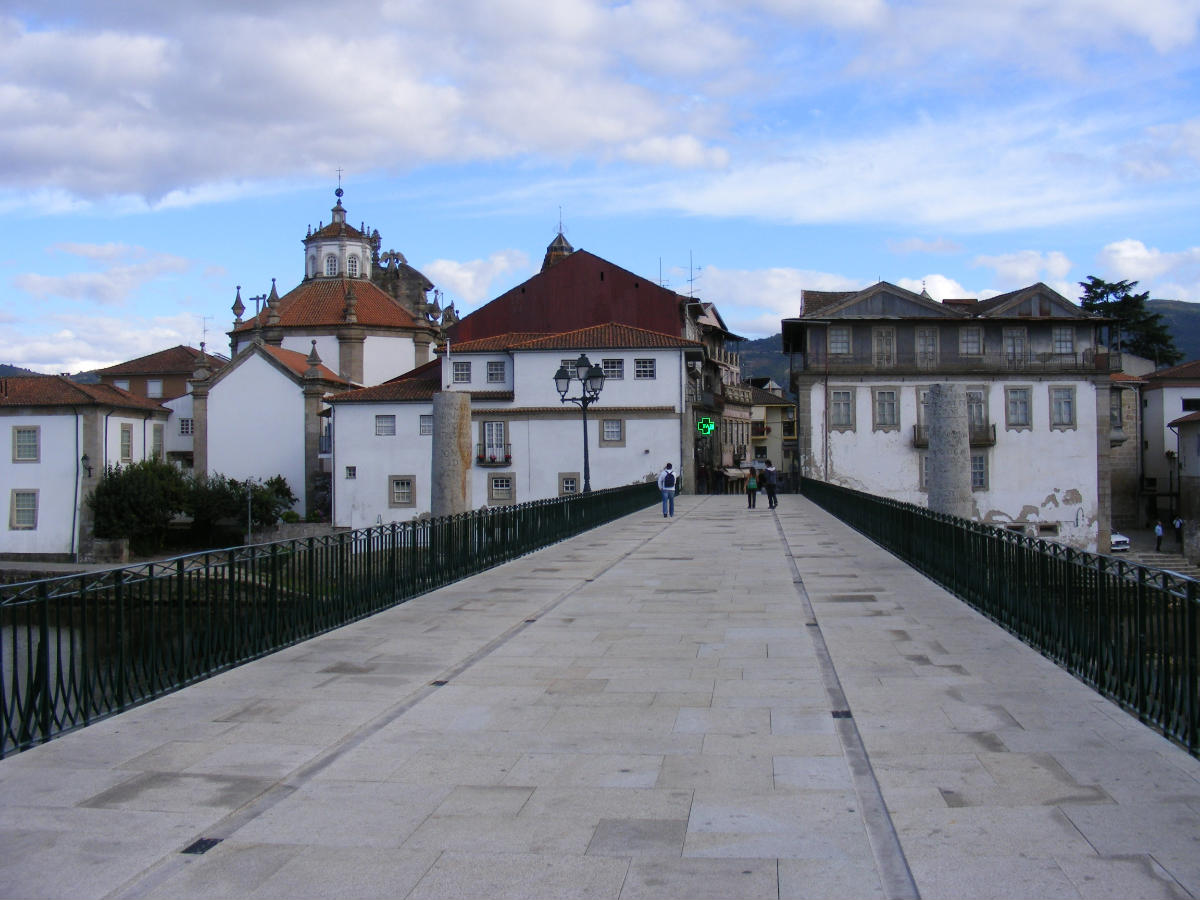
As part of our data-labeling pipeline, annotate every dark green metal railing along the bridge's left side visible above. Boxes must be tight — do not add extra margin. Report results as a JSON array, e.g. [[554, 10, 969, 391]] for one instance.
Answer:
[[0, 482, 660, 757]]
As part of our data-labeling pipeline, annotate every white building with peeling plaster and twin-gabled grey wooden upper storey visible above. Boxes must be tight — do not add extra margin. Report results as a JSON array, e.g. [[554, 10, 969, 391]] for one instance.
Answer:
[[784, 282, 1120, 550]]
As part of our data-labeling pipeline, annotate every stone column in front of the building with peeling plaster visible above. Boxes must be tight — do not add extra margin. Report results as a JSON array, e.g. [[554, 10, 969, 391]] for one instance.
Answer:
[[925, 384, 974, 518]]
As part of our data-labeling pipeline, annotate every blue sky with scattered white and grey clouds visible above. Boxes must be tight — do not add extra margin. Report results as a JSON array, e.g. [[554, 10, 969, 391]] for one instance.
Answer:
[[0, 0, 1200, 372]]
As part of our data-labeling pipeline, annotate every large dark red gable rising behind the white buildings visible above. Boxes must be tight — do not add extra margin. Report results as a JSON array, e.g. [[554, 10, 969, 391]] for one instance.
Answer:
[[450, 250, 688, 350]]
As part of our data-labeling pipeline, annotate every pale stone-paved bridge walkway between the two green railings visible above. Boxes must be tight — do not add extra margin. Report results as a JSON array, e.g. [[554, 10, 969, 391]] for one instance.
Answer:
[[0, 496, 1200, 900]]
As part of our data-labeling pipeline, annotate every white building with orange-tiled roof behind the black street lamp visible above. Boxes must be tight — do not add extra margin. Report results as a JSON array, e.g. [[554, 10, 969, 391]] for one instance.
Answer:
[[329, 324, 703, 528]]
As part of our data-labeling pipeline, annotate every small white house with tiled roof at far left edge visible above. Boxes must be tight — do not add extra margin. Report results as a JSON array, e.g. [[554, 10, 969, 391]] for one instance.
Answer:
[[0, 376, 168, 560]]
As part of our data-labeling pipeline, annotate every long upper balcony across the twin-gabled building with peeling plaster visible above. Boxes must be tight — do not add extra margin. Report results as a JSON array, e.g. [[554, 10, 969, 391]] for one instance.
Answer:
[[802, 348, 1121, 374]]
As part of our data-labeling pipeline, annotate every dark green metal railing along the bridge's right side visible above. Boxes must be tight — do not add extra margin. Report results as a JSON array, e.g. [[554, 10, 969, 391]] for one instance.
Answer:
[[800, 479, 1200, 756]]
